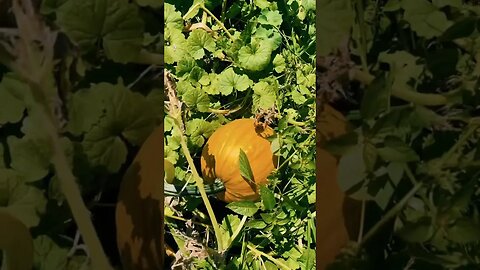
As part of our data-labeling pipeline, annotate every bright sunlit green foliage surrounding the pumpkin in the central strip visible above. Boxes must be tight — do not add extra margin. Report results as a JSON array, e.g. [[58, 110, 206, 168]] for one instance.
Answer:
[[164, 0, 316, 269]]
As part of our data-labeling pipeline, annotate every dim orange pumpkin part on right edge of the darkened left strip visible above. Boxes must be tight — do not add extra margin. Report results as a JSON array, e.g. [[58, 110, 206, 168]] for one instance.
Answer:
[[115, 126, 165, 270]]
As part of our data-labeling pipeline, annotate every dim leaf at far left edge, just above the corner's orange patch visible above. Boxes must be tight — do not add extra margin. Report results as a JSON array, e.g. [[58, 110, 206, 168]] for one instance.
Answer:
[[0, 169, 47, 228]]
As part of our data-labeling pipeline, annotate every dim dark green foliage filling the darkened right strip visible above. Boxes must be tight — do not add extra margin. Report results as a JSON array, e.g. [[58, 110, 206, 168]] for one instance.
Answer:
[[324, 0, 480, 269]]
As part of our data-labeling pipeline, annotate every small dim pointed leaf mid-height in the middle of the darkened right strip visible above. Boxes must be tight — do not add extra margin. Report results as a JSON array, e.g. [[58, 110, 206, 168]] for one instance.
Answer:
[[377, 136, 420, 163]]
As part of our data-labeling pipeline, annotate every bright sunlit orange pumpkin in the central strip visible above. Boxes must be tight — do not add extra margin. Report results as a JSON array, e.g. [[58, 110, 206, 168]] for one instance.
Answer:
[[200, 118, 278, 202]]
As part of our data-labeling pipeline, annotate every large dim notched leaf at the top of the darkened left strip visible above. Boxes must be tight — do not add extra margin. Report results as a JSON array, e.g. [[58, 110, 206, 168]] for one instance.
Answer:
[[57, 0, 144, 63]]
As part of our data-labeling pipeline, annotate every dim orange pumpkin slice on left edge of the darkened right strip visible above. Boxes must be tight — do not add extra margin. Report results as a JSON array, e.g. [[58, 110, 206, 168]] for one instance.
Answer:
[[316, 104, 361, 269]]
